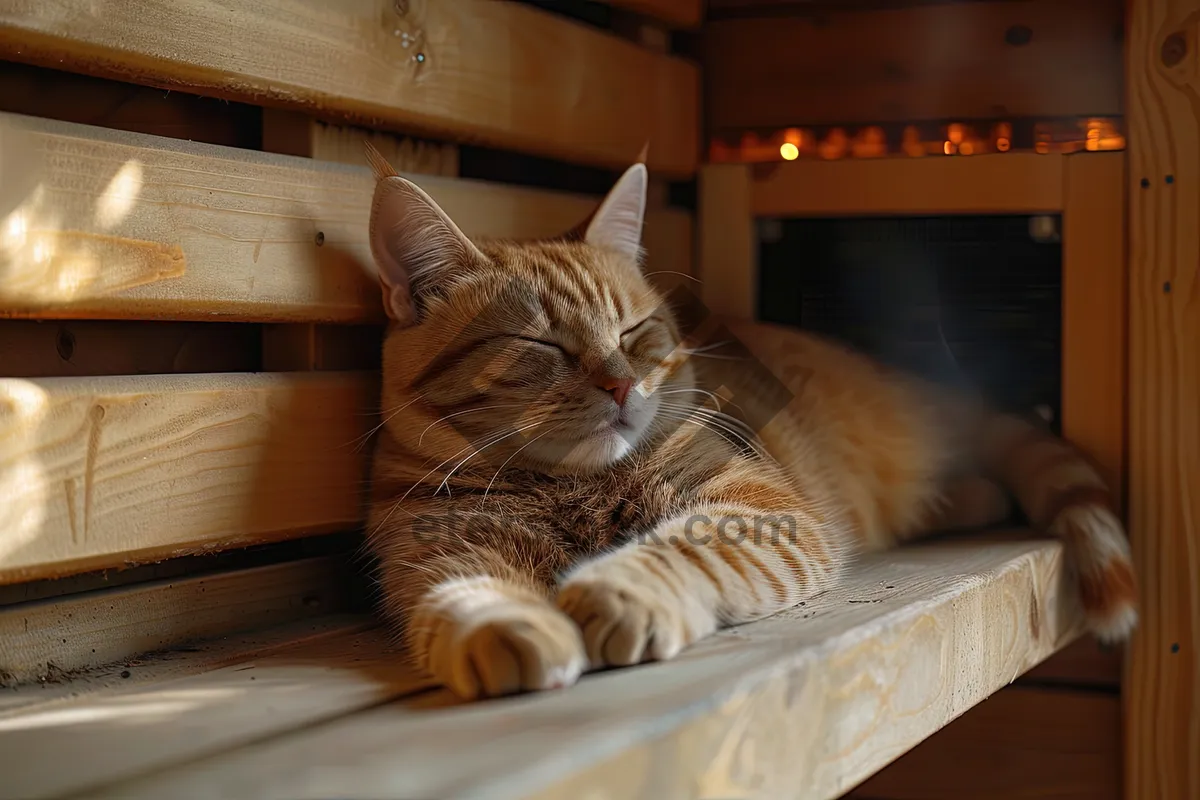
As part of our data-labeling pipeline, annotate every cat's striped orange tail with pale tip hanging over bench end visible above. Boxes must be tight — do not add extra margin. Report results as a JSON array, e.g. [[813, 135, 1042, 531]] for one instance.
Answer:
[[985, 414, 1138, 643]]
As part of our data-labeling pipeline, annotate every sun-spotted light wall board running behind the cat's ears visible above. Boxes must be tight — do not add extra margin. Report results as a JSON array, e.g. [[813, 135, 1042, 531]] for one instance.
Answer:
[[0, 114, 691, 323]]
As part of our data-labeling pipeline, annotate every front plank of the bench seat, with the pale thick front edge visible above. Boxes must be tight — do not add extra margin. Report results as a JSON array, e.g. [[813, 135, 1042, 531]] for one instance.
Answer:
[[89, 536, 1079, 800]]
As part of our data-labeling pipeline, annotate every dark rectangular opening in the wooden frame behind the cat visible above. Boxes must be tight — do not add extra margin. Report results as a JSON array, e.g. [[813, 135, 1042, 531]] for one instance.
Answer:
[[757, 209, 1062, 431]]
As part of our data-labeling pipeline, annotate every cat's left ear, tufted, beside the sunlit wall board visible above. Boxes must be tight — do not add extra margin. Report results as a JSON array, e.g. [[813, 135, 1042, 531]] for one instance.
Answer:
[[366, 143, 484, 325]]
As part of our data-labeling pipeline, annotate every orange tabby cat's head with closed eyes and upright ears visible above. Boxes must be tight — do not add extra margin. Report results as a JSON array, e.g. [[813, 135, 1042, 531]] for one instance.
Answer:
[[371, 148, 691, 473]]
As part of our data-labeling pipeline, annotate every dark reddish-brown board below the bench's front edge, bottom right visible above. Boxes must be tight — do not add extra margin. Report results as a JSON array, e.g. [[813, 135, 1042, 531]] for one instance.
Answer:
[[846, 686, 1121, 800]]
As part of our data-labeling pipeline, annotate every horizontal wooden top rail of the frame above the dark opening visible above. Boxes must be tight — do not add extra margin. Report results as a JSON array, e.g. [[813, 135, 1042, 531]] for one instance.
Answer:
[[751, 152, 1064, 217]]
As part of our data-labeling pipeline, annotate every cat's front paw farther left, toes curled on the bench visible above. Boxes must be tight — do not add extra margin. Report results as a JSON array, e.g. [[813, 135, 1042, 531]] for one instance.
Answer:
[[430, 603, 587, 699]]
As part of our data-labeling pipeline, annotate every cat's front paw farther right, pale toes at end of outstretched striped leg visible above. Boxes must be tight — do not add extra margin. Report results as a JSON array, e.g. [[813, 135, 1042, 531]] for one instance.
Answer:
[[557, 578, 715, 667]]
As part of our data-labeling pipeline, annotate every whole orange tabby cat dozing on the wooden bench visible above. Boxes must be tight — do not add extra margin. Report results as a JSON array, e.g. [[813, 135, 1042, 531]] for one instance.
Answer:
[[367, 146, 1136, 698]]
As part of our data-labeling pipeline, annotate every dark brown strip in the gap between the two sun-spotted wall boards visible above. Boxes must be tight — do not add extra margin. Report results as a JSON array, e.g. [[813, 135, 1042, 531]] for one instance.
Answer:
[[0, 319, 262, 378]]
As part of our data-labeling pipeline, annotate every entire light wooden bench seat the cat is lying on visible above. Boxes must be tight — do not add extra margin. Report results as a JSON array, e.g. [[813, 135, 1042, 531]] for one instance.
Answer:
[[0, 531, 1080, 800]]
